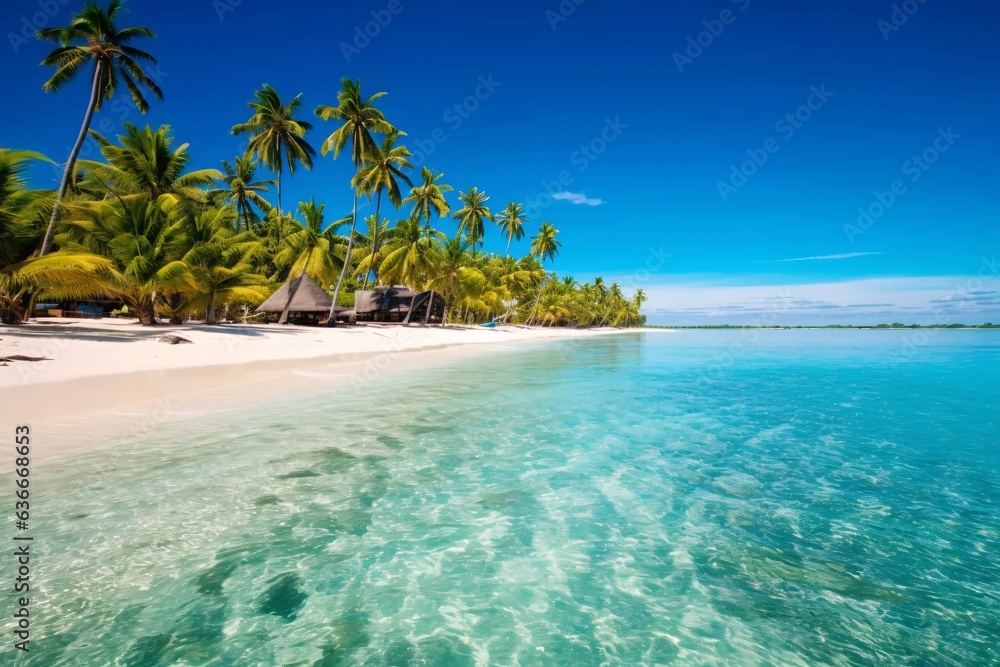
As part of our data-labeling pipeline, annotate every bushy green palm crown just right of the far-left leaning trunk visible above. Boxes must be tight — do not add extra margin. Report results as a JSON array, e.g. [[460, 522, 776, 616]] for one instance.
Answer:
[[79, 123, 222, 203]]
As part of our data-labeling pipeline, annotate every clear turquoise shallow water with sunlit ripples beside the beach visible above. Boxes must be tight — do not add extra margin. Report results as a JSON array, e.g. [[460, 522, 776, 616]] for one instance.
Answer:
[[9, 331, 1000, 667]]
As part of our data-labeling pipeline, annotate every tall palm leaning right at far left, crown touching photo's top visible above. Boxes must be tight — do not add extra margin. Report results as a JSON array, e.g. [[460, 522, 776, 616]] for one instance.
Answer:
[[38, 0, 163, 256]]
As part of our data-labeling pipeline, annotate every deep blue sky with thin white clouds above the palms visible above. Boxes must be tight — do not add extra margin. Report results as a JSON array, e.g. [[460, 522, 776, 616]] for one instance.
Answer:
[[0, 0, 1000, 324]]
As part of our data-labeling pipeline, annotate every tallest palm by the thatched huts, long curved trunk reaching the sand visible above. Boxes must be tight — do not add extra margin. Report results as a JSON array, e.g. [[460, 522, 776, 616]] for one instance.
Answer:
[[315, 78, 396, 326]]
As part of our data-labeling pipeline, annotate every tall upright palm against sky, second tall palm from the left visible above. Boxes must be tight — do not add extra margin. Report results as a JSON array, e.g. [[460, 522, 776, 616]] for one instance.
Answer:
[[232, 83, 316, 214]]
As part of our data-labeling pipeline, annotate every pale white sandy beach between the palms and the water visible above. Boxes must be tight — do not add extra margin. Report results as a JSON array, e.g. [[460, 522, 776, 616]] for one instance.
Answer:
[[0, 319, 636, 458]]
